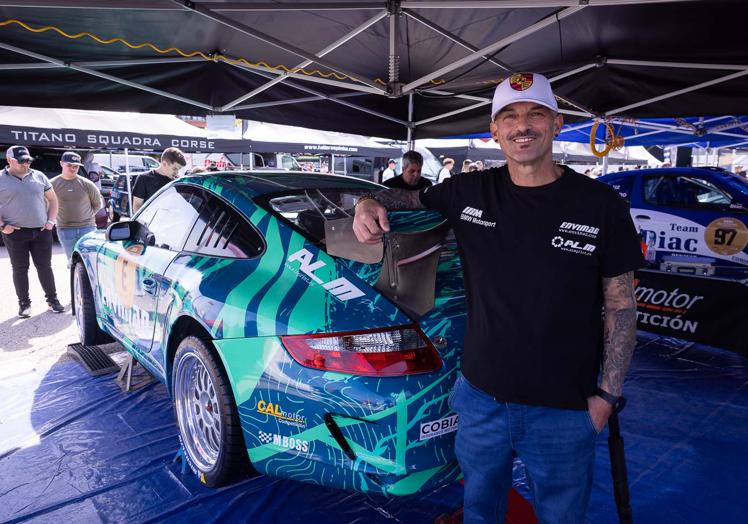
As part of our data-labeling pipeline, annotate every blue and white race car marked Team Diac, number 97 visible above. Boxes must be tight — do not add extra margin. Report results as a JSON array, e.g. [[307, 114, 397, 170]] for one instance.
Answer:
[[598, 168, 748, 276]]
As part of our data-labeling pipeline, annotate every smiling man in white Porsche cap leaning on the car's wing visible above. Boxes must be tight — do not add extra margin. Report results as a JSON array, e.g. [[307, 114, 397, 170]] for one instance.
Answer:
[[353, 73, 643, 523]]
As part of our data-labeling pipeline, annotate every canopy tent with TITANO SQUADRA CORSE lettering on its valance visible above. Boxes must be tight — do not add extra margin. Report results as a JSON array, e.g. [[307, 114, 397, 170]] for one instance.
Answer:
[[0, 106, 250, 152]]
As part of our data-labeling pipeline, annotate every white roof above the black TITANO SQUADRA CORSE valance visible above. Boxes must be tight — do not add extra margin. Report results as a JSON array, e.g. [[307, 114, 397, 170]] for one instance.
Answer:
[[0, 106, 206, 137]]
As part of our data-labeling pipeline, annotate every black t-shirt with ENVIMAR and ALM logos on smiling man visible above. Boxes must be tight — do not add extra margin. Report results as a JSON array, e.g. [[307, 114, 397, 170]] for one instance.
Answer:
[[420, 166, 643, 410]]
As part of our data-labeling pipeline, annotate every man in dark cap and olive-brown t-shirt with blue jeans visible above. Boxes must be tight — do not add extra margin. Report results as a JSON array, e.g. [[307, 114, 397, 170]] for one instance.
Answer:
[[52, 151, 102, 267]]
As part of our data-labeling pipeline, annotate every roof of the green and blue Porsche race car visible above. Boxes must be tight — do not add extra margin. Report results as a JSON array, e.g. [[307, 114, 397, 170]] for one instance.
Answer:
[[179, 170, 382, 198]]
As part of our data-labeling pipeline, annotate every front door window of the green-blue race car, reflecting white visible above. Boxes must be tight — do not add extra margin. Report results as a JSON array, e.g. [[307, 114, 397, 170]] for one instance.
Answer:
[[135, 185, 206, 251]]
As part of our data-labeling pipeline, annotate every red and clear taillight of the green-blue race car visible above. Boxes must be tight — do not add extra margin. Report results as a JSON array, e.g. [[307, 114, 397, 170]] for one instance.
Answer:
[[281, 326, 442, 377]]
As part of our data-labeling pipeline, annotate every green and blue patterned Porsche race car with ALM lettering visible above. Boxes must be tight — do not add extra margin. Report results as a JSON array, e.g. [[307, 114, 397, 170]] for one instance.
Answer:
[[71, 171, 466, 495]]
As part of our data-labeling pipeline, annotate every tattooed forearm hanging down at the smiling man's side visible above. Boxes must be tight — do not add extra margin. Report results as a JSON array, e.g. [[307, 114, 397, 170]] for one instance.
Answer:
[[601, 272, 636, 396]]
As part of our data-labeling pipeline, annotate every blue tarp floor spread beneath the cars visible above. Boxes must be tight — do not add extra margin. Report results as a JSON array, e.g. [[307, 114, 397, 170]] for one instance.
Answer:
[[0, 333, 748, 524]]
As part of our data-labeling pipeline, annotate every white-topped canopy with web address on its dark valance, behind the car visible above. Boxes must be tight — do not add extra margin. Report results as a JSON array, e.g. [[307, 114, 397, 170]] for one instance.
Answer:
[[244, 121, 401, 157]]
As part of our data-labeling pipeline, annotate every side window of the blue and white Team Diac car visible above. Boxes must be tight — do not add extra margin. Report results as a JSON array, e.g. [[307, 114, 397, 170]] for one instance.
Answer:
[[644, 175, 732, 210]]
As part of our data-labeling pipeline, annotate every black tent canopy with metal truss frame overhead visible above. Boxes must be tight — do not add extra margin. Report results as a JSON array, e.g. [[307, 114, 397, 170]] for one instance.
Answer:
[[0, 0, 748, 139]]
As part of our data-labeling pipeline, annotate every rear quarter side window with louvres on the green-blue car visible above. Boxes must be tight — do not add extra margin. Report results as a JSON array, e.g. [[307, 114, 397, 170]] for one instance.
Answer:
[[184, 195, 265, 258]]
